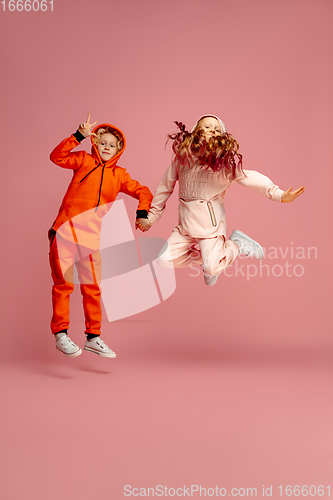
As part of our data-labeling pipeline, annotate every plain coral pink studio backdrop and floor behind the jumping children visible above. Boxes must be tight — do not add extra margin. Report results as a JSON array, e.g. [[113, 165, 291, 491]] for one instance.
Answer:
[[0, 0, 333, 500]]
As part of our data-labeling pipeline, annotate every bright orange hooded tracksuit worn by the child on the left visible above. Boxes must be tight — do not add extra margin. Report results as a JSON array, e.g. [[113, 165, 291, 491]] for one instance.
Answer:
[[49, 123, 153, 335]]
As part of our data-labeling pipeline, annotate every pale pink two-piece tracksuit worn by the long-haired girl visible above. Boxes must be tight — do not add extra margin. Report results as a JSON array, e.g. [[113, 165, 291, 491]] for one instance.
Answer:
[[148, 120, 283, 276]]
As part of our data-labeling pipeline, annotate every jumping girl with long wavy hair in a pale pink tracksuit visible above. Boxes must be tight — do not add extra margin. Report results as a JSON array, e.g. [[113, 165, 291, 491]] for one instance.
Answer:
[[136, 115, 305, 286]]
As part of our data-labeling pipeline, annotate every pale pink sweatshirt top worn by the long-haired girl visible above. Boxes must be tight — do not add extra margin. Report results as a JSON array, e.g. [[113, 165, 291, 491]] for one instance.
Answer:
[[148, 163, 283, 238]]
